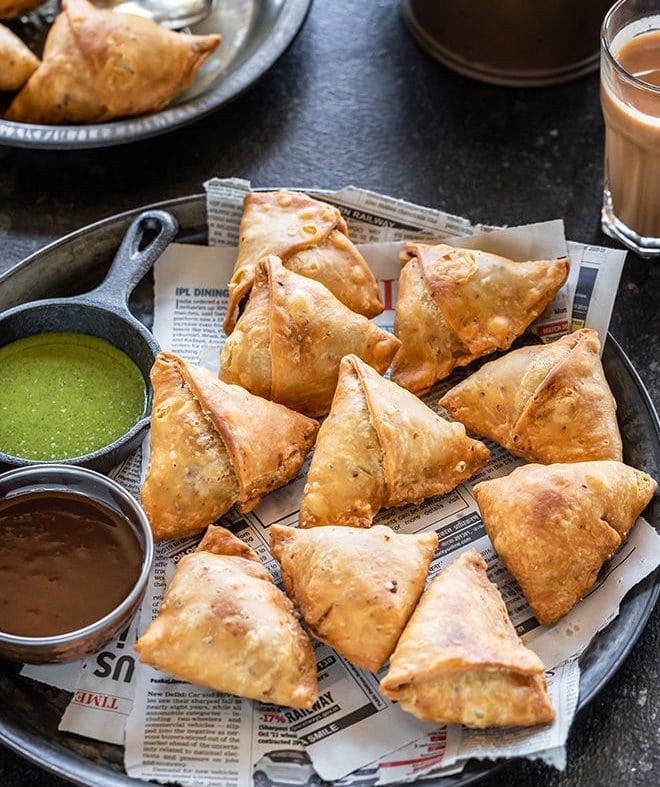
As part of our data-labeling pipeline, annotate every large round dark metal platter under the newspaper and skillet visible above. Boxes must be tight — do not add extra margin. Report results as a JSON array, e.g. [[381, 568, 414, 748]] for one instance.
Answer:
[[0, 195, 660, 787]]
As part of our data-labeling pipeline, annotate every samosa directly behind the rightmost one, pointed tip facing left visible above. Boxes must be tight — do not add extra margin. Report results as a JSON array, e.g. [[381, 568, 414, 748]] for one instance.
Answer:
[[440, 328, 622, 464]]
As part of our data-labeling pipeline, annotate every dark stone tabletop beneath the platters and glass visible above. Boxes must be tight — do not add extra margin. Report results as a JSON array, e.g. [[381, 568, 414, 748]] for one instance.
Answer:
[[0, 0, 660, 787]]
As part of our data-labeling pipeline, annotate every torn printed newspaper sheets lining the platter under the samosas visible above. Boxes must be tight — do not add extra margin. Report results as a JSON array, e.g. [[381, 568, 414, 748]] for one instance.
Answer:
[[22, 179, 660, 787]]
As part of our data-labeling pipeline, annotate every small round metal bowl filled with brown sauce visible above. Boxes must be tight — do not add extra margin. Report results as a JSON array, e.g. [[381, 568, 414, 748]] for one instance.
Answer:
[[0, 464, 154, 664]]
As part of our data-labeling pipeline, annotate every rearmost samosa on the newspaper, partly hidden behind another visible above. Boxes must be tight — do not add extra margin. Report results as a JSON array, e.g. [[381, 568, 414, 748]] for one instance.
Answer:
[[225, 189, 383, 334]]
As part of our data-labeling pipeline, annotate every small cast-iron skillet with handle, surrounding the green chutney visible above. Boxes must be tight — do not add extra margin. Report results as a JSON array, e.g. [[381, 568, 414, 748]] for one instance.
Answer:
[[0, 210, 178, 473]]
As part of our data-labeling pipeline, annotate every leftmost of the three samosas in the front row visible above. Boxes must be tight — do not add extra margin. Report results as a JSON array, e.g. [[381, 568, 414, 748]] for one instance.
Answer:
[[135, 526, 318, 708]]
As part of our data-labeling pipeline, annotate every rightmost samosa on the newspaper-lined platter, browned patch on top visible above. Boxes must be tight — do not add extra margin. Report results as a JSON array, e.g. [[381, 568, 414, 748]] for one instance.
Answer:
[[474, 461, 656, 626]]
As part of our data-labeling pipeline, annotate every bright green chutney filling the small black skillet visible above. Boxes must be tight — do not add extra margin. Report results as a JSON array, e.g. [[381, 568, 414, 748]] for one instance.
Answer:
[[0, 332, 147, 461]]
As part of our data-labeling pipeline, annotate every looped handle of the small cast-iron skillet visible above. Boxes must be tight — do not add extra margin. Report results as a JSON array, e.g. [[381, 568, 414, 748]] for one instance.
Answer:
[[83, 210, 179, 309]]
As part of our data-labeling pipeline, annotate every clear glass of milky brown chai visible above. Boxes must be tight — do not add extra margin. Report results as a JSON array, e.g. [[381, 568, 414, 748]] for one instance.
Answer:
[[600, 0, 660, 257]]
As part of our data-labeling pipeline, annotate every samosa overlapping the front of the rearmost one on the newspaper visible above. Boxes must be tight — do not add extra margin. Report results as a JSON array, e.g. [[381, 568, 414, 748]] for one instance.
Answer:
[[220, 255, 399, 416]]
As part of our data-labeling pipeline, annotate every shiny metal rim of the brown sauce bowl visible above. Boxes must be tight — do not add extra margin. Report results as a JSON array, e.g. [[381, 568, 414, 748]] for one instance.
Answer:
[[0, 463, 155, 652]]
